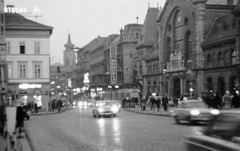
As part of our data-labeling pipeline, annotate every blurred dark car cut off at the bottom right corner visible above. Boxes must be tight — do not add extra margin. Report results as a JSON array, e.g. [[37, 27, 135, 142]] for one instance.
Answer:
[[184, 109, 240, 151]]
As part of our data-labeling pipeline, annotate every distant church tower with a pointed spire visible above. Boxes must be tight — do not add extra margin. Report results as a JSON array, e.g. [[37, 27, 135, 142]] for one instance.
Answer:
[[63, 33, 76, 69]]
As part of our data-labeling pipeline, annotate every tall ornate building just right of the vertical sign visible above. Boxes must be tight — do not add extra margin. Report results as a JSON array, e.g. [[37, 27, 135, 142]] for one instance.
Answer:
[[117, 24, 142, 89]]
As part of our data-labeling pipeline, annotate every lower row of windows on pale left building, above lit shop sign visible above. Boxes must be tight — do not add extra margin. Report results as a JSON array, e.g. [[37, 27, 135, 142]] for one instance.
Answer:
[[8, 63, 42, 79]]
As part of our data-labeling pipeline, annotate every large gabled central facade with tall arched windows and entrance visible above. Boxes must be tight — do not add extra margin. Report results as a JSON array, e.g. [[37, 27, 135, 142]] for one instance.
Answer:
[[157, 0, 237, 97]]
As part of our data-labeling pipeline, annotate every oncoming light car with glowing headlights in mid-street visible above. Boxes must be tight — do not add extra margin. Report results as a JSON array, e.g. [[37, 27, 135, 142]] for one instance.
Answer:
[[92, 100, 120, 118]]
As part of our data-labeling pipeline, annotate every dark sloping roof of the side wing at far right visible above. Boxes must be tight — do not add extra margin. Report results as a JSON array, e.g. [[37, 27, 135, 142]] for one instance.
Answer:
[[202, 14, 237, 47]]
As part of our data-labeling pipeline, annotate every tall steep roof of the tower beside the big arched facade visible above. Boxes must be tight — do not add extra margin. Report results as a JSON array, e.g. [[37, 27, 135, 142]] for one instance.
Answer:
[[136, 8, 159, 49]]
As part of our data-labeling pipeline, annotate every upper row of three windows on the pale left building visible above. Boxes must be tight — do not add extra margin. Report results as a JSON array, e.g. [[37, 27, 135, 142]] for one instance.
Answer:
[[6, 42, 40, 54]]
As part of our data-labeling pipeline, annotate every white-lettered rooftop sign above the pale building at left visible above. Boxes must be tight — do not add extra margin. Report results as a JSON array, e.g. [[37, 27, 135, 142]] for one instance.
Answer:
[[4, 6, 42, 16]]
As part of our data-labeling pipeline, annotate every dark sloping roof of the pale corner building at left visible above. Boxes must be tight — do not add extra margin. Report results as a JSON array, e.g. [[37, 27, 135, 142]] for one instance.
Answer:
[[5, 13, 53, 33]]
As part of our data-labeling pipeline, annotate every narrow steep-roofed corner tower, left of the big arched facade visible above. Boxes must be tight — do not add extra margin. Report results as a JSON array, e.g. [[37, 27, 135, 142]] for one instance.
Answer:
[[134, 7, 160, 95]]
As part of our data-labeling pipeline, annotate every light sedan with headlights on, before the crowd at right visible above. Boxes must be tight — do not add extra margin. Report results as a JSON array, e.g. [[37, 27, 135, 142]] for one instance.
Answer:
[[170, 100, 219, 124]]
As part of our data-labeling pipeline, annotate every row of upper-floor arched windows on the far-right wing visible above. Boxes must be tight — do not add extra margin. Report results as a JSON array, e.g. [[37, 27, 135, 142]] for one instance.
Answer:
[[206, 50, 236, 67]]
